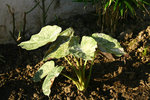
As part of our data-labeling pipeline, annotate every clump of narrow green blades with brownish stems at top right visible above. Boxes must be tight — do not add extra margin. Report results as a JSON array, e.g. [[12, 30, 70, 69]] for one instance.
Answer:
[[74, 0, 150, 35]]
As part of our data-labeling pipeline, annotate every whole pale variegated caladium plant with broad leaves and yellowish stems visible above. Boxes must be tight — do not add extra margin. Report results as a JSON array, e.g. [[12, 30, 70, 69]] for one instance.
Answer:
[[19, 25, 125, 96]]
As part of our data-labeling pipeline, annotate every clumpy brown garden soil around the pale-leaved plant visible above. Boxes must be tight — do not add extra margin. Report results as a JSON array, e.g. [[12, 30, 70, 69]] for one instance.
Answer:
[[0, 13, 150, 100]]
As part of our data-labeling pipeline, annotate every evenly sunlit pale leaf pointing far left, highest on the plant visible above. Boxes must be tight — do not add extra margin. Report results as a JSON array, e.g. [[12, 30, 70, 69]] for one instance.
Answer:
[[19, 25, 61, 50]]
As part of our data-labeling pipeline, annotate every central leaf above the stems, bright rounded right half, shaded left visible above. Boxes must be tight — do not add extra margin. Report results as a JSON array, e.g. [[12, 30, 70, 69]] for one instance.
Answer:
[[70, 36, 97, 60]]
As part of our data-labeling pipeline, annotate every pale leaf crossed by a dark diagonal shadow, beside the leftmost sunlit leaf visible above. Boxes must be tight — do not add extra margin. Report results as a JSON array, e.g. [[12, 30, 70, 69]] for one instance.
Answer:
[[44, 28, 74, 60]]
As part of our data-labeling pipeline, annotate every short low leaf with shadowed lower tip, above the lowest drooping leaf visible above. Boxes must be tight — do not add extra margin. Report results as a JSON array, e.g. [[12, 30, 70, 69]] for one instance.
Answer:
[[33, 61, 55, 82]]
